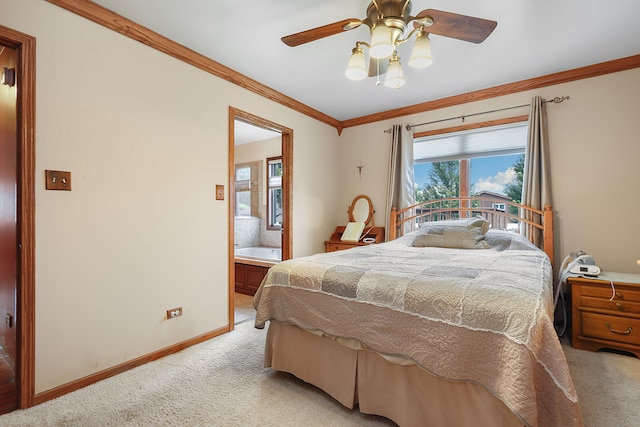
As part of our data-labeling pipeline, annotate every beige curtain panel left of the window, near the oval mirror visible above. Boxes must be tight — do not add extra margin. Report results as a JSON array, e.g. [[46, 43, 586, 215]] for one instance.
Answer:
[[385, 124, 415, 240]]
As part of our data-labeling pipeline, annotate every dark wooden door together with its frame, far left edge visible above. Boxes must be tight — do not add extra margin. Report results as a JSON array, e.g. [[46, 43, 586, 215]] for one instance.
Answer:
[[0, 25, 39, 411]]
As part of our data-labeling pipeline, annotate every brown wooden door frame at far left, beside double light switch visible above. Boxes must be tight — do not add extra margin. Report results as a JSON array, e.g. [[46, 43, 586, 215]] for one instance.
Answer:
[[0, 25, 36, 408]]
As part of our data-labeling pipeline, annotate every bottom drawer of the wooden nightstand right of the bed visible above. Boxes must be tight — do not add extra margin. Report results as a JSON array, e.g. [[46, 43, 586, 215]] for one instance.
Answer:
[[581, 312, 640, 345]]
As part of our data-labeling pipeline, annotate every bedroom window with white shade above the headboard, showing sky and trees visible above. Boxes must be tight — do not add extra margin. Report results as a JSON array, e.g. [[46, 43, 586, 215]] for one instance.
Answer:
[[413, 122, 527, 204]]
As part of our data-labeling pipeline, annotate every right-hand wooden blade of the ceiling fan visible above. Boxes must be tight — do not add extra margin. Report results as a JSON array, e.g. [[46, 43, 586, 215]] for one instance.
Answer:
[[413, 9, 498, 43]]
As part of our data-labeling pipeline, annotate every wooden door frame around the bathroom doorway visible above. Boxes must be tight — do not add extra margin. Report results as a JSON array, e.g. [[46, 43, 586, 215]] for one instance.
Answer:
[[227, 107, 293, 330]]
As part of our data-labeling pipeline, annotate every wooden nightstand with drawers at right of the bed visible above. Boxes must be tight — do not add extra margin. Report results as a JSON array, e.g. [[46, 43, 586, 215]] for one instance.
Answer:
[[567, 272, 640, 357]]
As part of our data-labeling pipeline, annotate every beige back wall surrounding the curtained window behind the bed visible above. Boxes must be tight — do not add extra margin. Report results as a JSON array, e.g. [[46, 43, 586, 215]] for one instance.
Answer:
[[340, 69, 640, 273]]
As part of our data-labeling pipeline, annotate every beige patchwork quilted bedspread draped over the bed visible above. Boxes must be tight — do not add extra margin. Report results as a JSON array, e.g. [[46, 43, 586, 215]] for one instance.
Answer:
[[255, 236, 580, 426]]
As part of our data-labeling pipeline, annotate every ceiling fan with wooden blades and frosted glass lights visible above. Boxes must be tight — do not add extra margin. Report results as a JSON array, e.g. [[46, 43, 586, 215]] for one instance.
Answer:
[[281, 0, 498, 88]]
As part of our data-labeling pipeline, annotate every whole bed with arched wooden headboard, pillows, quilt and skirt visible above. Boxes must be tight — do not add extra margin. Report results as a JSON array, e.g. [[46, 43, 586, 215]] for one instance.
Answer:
[[254, 198, 582, 426]]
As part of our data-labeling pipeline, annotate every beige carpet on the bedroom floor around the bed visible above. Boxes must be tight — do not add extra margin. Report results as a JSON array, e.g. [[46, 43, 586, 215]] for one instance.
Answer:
[[0, 321, 640, 427]]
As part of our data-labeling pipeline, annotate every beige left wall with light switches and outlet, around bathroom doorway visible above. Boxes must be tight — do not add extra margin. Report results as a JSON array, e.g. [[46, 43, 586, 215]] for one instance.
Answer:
[[0, 0, 339, 392]]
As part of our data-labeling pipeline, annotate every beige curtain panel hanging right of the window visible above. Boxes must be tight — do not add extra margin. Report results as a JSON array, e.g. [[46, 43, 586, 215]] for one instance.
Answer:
[[522, 96, 551, 245]]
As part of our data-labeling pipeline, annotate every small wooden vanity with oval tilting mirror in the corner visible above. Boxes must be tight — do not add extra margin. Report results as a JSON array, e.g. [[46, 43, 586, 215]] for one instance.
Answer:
[[324, 195, 384, 252]]
